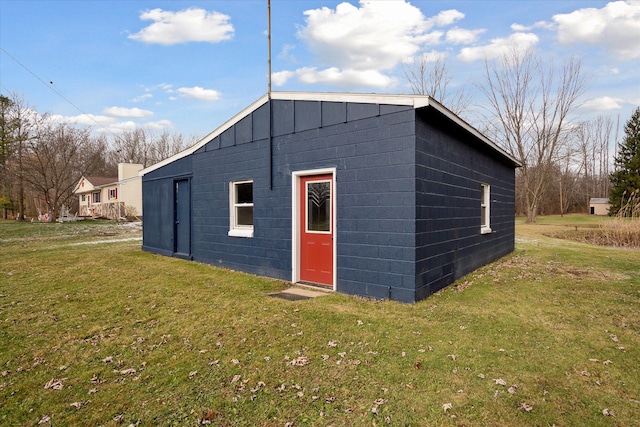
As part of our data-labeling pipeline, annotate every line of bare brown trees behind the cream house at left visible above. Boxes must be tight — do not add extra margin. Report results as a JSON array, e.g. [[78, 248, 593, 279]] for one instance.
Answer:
[[0, 95, 195, 219]]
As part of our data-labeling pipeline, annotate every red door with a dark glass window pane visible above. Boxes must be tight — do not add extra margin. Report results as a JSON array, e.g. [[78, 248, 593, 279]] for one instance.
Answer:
[[300, 174, 333, 286]]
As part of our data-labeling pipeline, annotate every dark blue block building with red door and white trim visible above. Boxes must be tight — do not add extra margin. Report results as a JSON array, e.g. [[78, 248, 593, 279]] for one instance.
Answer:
[[141, 92, 520, 302]]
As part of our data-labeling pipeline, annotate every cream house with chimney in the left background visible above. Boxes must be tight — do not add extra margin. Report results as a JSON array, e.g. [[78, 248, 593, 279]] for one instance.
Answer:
[[73, 163, 143, 219]]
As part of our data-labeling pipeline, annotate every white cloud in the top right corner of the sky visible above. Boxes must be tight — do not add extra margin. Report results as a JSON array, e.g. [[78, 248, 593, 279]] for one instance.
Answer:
[[552, 0, 640, 59]]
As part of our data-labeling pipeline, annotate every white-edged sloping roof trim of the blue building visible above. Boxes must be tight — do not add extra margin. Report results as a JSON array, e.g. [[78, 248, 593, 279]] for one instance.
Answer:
[[139, 92, 522, 176]]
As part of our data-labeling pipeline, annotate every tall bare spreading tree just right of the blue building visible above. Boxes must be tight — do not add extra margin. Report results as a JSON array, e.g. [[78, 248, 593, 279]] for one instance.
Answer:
[[482, 49, 586, 223]]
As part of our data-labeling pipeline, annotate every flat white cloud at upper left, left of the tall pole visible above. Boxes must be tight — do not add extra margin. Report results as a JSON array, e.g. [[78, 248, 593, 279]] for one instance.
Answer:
[[129, 8, 234, 45]]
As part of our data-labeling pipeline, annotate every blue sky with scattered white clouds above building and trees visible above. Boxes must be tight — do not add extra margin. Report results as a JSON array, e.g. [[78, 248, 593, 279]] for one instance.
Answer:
[[0, 0, 640, 139]]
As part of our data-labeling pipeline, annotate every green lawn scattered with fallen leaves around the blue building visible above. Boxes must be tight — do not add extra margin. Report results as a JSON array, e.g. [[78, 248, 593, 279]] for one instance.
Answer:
[[0, 216, 640, 426]]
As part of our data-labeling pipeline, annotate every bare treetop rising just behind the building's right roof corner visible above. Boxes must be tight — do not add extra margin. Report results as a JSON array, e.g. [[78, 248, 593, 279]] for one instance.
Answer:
[[403, 52, 472, 116]]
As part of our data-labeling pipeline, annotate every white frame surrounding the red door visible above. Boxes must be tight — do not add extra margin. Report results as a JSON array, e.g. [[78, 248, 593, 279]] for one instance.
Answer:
[[291, 168, 338, 291]]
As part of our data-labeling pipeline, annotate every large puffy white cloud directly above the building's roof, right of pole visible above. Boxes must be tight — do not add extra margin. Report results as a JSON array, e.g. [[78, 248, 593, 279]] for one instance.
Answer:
[[280, 0, 474, 89]]
